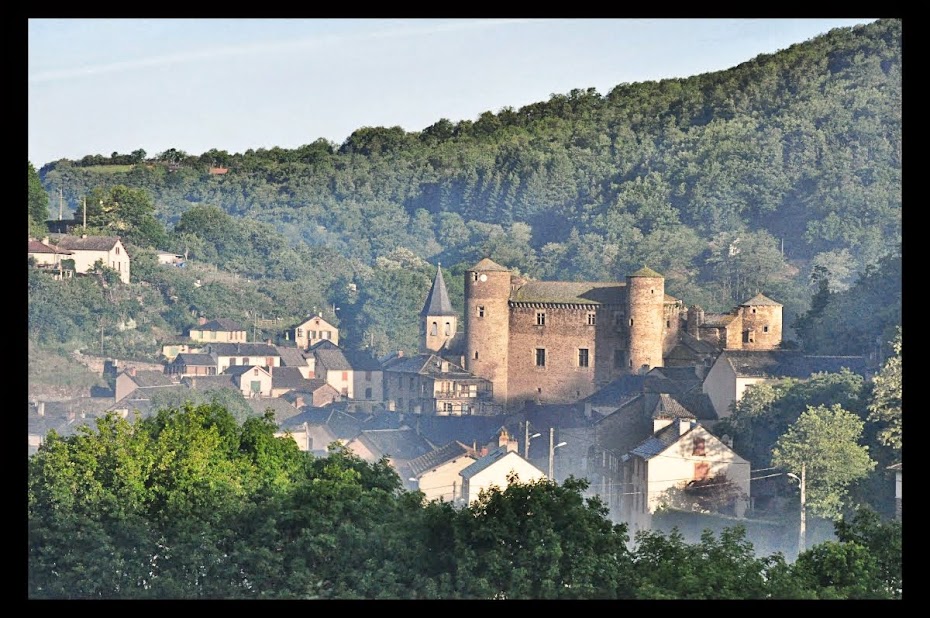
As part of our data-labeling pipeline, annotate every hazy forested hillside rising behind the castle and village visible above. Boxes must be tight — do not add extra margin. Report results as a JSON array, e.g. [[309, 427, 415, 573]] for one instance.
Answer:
[[30, 20, 902, 354]]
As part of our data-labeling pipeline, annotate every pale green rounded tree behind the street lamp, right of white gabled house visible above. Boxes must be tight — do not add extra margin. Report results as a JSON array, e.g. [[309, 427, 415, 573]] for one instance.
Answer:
[[772, 404, 875, 520]]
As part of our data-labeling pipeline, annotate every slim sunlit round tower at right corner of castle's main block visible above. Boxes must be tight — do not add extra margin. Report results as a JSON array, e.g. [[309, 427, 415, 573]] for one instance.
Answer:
[[626, 266, 665, 373]]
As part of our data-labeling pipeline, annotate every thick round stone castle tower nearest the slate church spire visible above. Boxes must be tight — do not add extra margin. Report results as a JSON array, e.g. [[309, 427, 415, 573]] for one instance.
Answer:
[[465, 258, 511, 404]]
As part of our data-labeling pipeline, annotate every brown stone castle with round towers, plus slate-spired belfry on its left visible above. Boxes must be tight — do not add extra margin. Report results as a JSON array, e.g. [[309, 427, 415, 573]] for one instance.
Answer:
[[420, 258, 782, 407]]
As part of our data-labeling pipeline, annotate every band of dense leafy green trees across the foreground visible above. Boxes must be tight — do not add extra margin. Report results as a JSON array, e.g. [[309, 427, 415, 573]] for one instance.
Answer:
[[28, 404, 903, 600]]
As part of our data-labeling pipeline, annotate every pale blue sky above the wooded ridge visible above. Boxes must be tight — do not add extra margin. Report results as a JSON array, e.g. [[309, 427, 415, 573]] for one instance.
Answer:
[[28, 18, 875, 169]]
